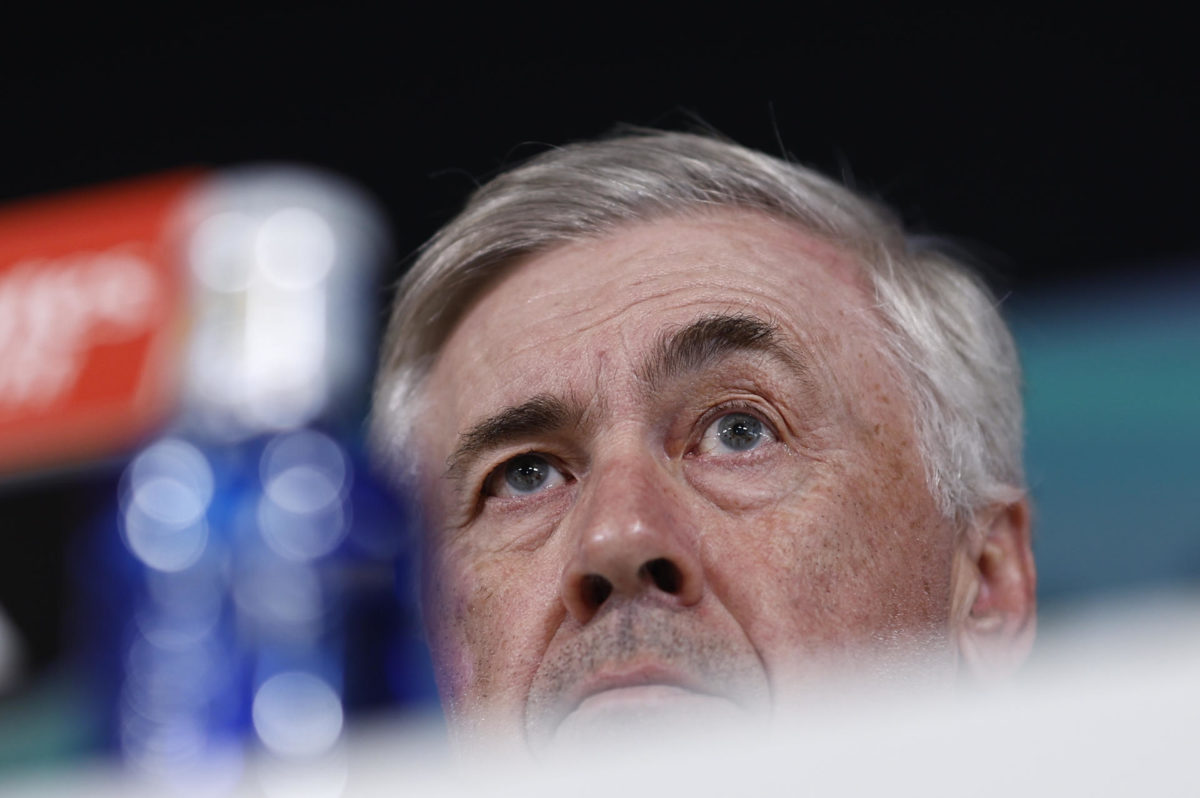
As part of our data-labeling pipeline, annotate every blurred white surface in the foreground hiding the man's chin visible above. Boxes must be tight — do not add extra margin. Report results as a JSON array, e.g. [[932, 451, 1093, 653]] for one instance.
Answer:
[[9, 595, 1200, 798]]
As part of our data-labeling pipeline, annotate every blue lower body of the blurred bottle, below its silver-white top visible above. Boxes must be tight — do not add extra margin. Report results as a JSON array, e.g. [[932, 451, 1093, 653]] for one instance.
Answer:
[[76, 428, 434, 780]]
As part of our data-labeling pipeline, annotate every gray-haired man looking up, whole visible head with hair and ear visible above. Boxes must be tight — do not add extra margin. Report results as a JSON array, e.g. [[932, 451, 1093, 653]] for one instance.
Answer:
[[373, 127, 1034, 750]]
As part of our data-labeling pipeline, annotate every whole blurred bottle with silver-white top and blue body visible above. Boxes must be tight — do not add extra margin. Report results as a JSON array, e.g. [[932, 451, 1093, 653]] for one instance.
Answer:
[[58, 168, 433, 786]]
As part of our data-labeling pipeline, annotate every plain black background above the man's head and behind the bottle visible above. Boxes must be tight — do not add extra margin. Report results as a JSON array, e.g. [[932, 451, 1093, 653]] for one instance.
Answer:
[[0, 2, 1200, 686]]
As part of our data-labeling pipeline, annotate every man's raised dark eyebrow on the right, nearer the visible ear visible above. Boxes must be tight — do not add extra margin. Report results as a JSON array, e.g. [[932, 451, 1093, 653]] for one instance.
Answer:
[[640, 313, 811, 386]]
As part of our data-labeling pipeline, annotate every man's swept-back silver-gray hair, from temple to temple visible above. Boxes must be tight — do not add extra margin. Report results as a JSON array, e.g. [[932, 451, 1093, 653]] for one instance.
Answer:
[[371, 131, 1024, 522]]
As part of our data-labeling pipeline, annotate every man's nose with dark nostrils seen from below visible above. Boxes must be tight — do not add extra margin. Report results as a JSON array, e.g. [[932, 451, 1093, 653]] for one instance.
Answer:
[[562, 457, 704, 624]]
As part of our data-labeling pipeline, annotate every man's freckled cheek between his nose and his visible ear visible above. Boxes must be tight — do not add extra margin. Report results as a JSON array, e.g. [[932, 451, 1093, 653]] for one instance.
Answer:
[[707, 458, 950, 667]]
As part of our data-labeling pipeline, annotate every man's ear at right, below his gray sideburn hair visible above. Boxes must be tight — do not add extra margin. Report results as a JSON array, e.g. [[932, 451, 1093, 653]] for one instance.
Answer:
[[954, 496, 1037, 680]]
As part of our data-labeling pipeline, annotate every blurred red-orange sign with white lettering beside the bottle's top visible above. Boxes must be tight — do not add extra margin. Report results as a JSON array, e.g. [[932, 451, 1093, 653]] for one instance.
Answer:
[[0, 173, 202, 473]]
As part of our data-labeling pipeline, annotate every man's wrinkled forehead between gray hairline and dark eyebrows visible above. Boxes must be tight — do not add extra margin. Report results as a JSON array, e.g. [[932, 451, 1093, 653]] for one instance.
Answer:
[[427, 211, 874, 448]]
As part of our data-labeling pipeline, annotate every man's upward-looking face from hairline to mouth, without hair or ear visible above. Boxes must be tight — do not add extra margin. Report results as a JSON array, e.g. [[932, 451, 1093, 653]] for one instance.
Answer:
[[415, 211, 961, 749]]
